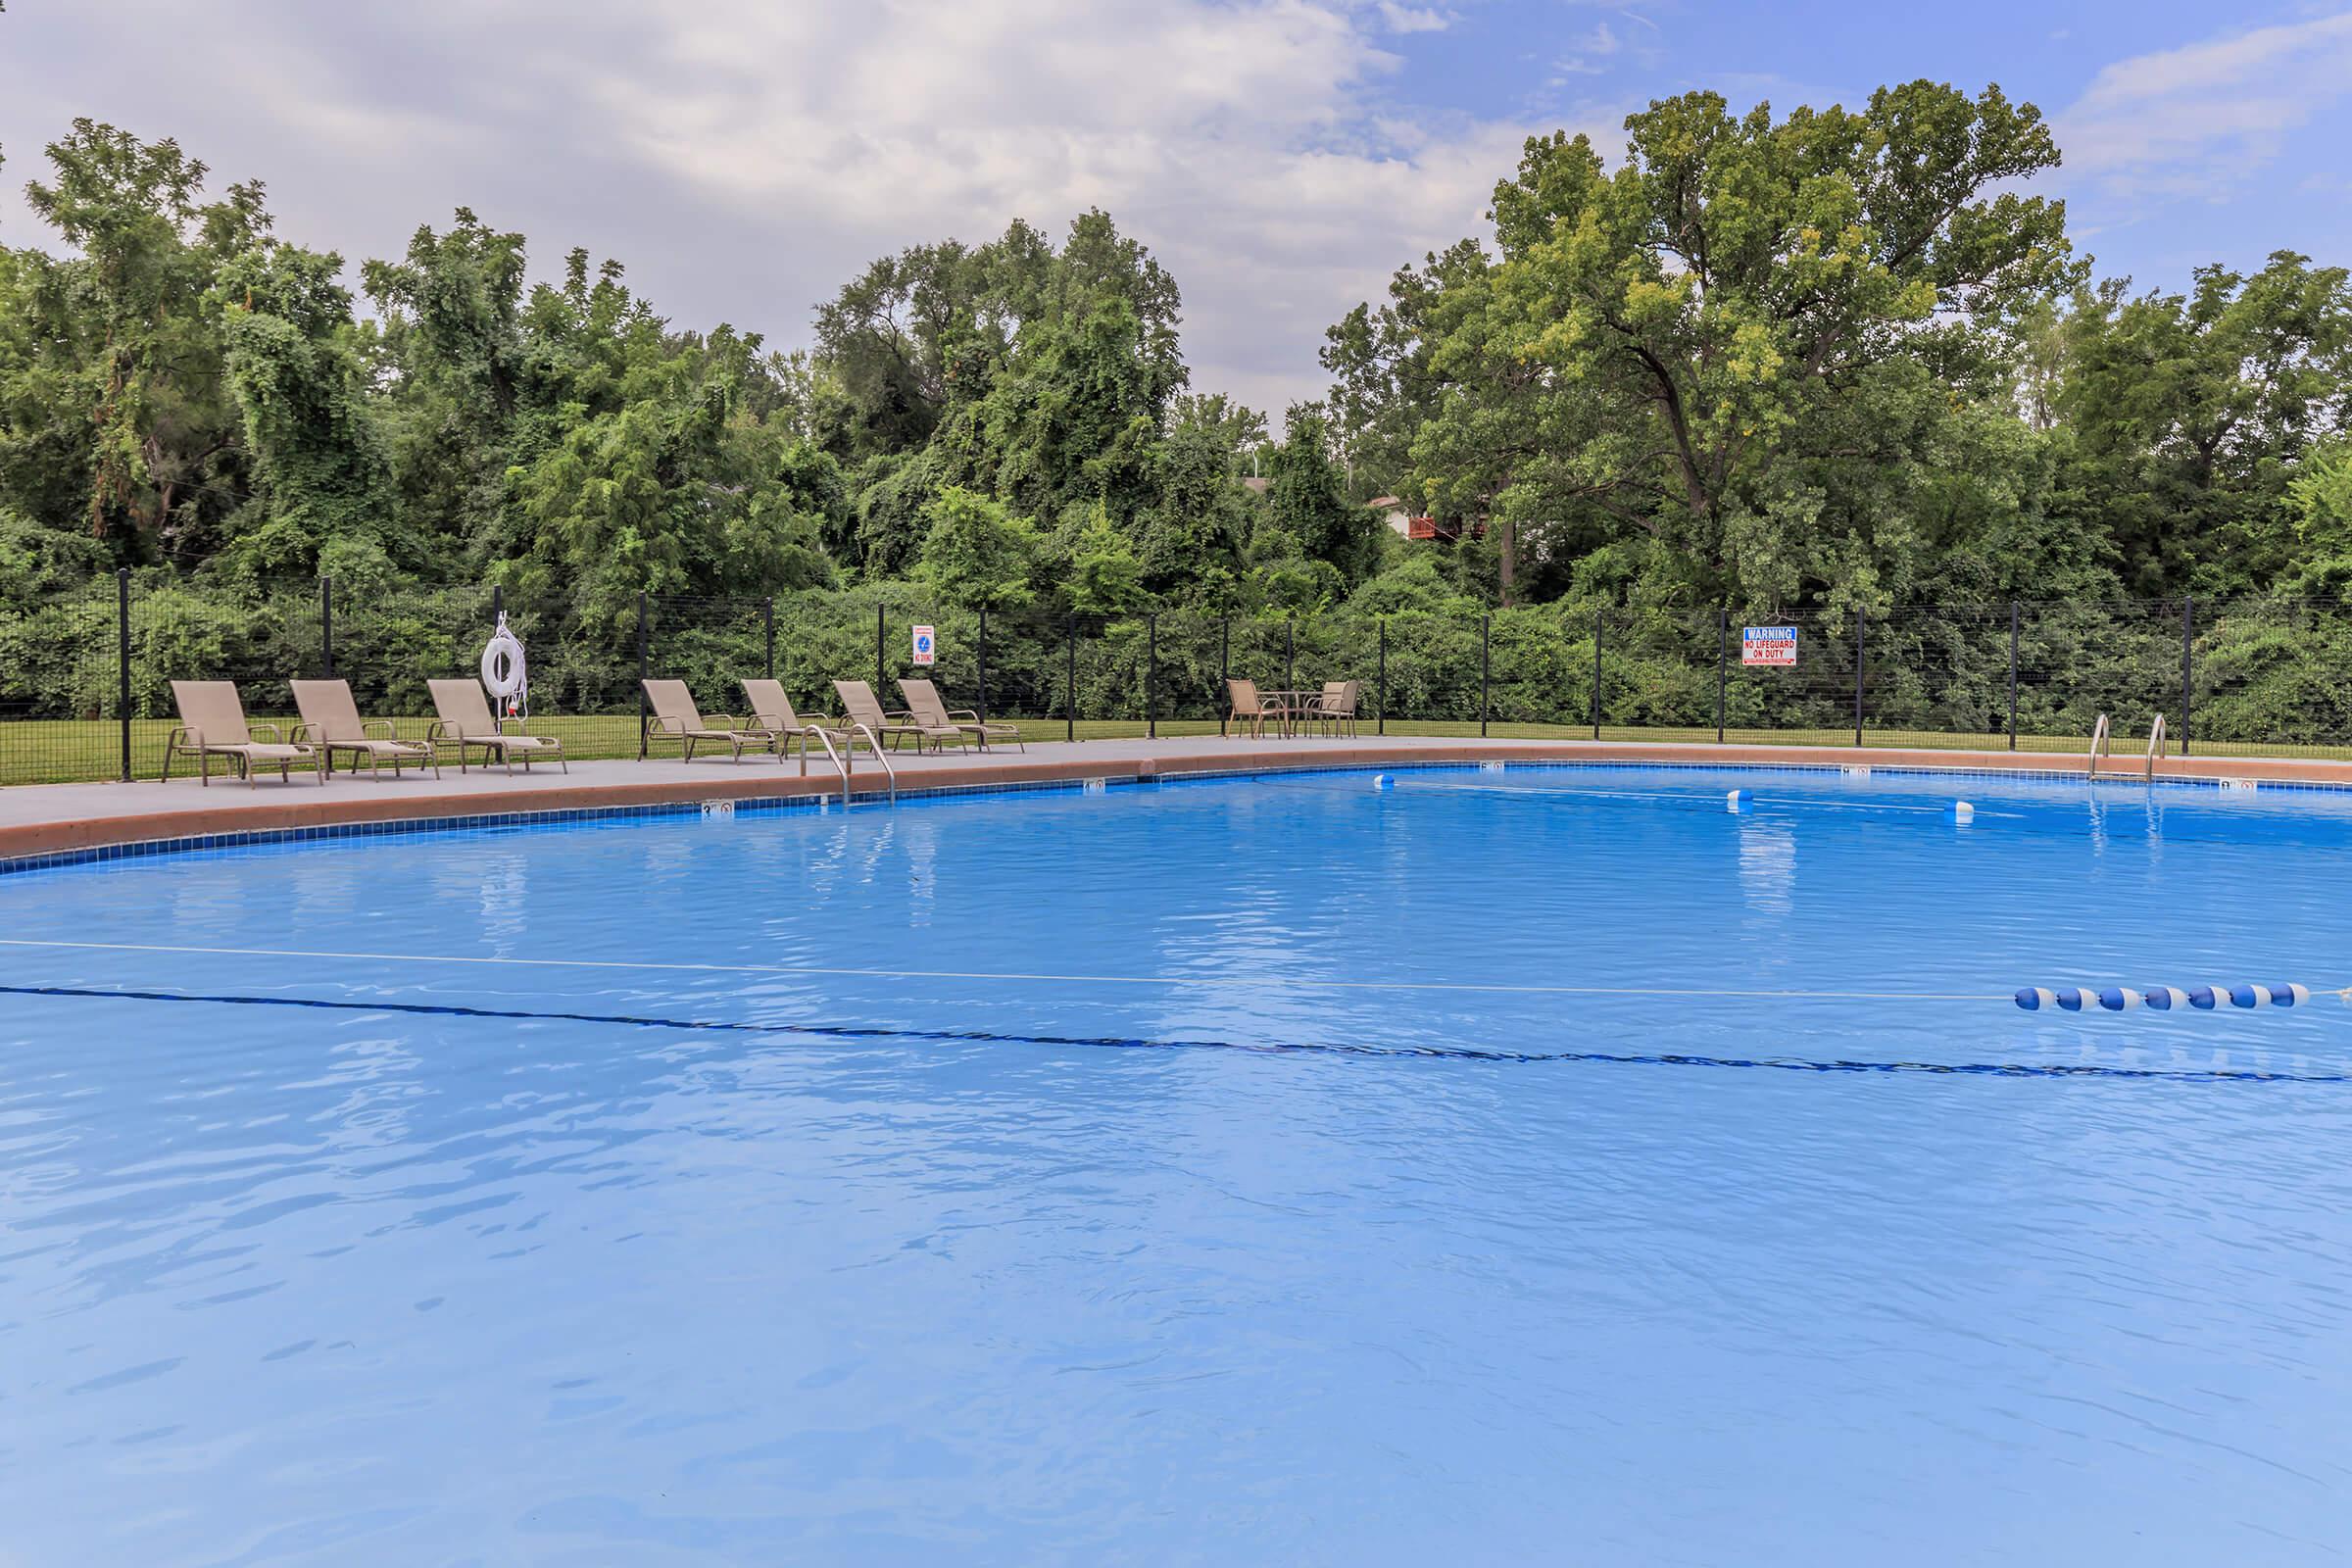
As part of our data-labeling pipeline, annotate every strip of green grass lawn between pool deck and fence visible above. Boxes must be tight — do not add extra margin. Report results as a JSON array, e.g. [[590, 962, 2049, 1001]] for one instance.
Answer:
[[0, 712, 2305, 785]]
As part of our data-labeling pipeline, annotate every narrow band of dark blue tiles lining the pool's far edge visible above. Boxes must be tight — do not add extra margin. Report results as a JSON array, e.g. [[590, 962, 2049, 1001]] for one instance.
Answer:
[[0, 757, 2352, 877]]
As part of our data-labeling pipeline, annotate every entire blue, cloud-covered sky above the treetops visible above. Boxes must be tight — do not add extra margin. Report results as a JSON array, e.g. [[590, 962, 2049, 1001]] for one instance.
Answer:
[[0, 0, 2352, 420]]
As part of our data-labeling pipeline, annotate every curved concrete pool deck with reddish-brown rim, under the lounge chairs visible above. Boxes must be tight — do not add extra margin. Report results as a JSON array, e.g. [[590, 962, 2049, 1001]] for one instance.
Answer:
[[0, 736, 2352, 860]]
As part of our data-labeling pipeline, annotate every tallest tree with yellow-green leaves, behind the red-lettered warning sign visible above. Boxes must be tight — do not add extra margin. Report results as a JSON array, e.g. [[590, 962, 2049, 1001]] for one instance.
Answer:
[[1383, 82, 2075, 604]]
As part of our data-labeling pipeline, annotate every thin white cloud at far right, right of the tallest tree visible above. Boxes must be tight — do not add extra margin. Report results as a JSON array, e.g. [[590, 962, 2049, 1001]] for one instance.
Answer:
[[2053, 12, 2352, 193]]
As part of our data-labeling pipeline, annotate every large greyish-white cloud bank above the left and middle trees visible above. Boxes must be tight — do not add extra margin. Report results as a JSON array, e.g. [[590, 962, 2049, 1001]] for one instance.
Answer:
[[0, 0, 1547, 414]]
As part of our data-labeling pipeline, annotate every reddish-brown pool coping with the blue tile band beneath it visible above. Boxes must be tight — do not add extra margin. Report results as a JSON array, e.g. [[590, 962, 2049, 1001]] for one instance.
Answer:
[[0, 741, 2352, 877]]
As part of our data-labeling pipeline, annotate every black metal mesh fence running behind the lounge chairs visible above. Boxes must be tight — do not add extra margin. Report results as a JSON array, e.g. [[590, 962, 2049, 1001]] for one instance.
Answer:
[[0, 573, 2352, 785]]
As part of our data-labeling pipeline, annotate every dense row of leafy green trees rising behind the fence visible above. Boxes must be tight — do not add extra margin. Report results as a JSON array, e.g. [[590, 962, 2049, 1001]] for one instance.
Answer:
[[0, 82, 2352, 642]]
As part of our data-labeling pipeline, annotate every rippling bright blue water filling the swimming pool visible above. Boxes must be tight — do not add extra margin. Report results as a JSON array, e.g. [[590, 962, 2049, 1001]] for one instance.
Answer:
[[0, 768, 2352, 1563]]
